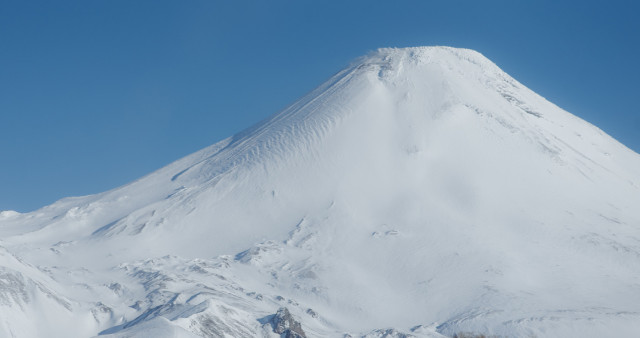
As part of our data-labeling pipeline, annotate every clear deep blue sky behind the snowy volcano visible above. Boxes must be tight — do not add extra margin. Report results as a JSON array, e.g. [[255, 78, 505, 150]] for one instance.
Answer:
[[0, 0, 640, 212]]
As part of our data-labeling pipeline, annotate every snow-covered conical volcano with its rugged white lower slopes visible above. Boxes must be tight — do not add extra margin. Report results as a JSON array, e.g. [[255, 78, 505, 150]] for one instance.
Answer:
[[0, 47, 640, 337]]
